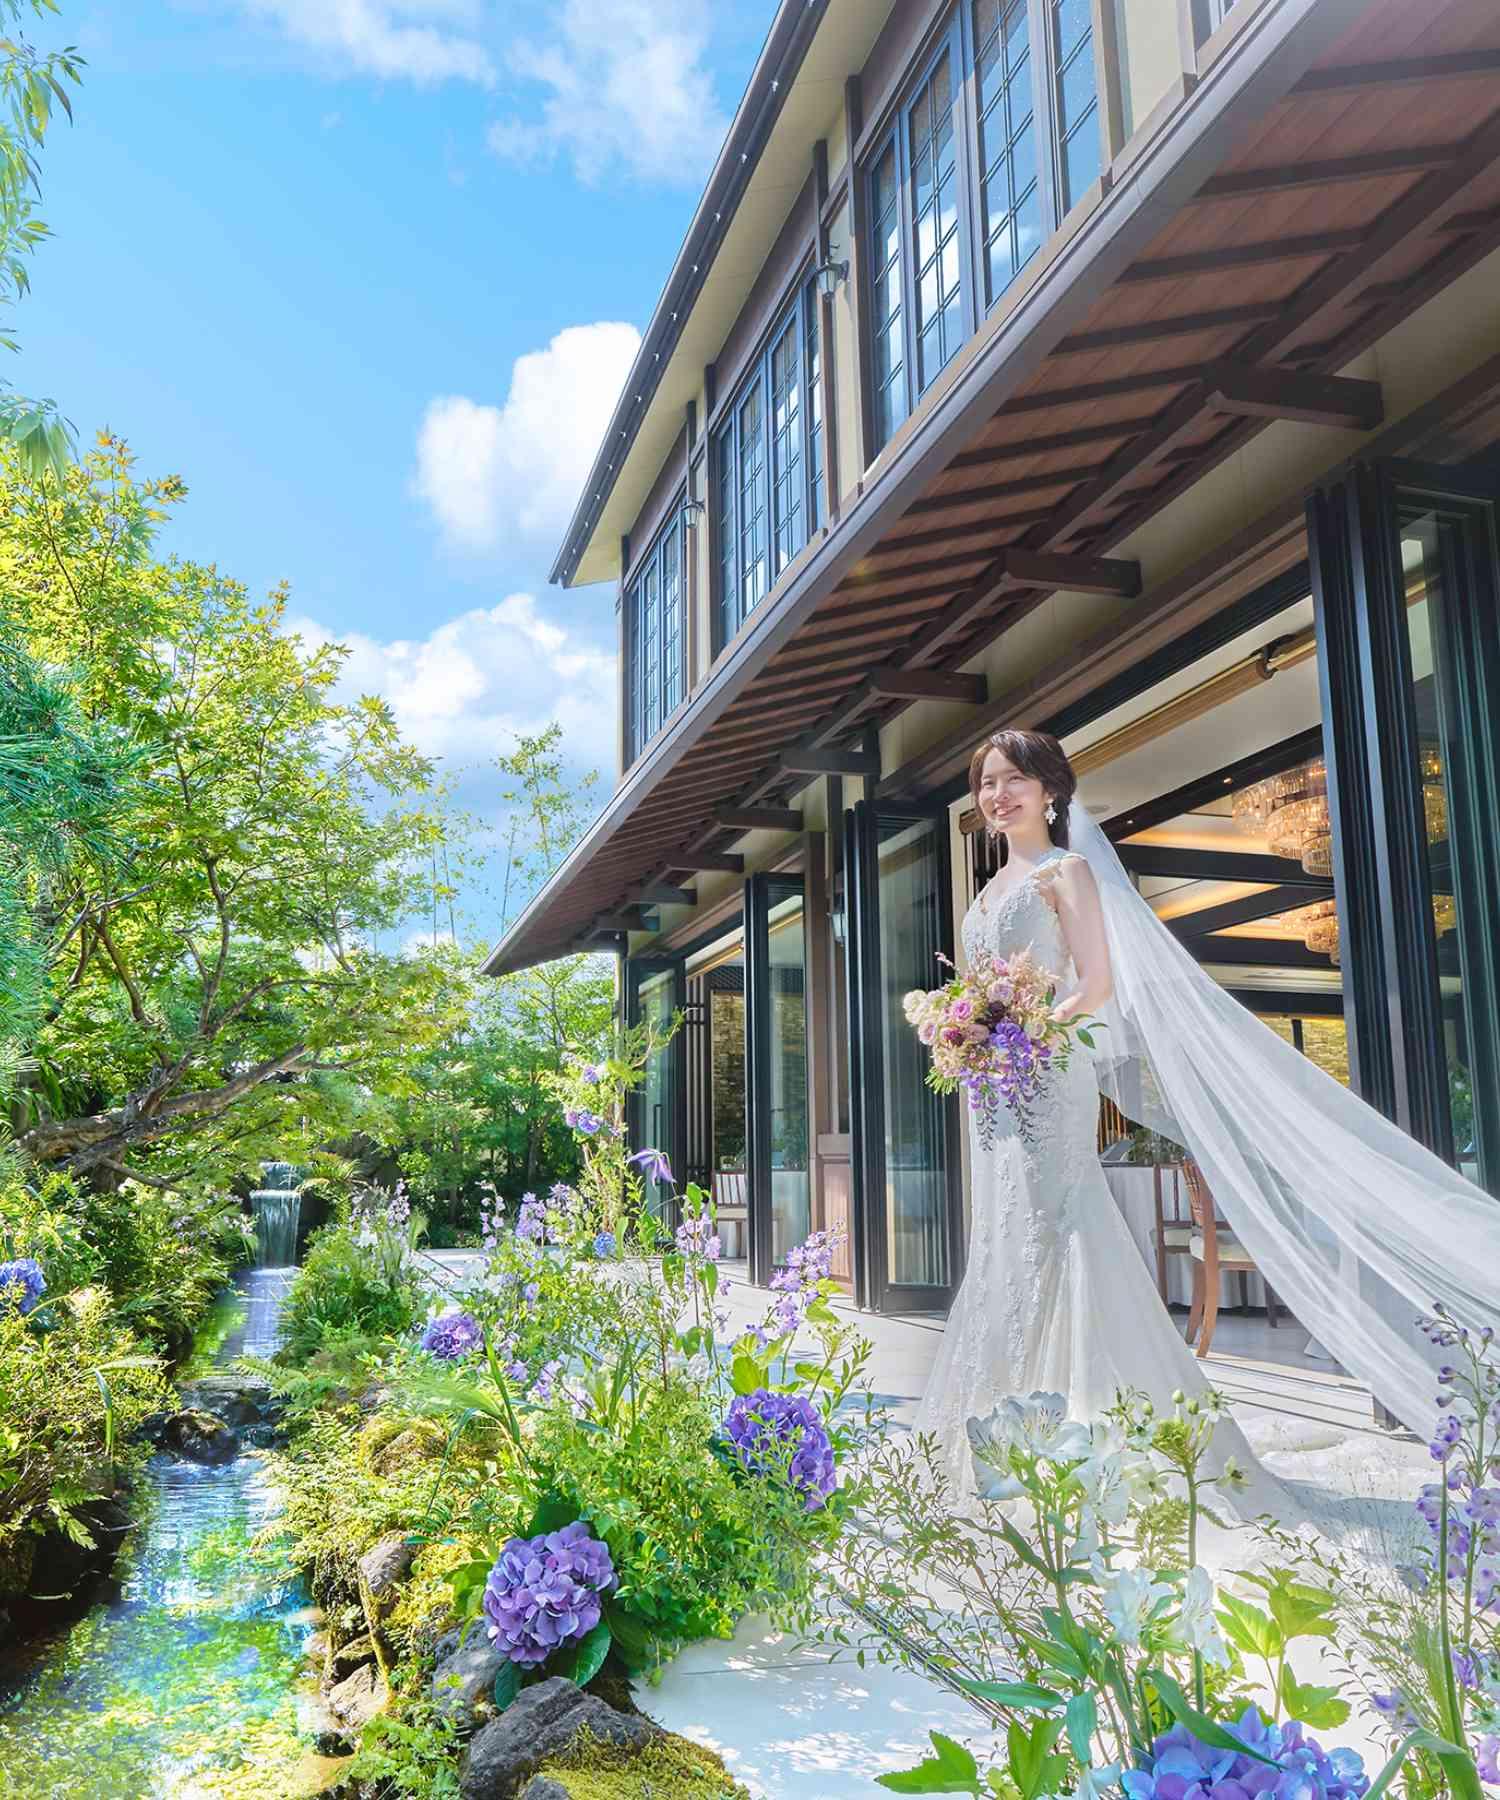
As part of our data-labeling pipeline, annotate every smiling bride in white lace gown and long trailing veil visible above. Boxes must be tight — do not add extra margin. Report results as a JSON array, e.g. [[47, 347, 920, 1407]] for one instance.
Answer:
[[917, 731, 1500, 1514]]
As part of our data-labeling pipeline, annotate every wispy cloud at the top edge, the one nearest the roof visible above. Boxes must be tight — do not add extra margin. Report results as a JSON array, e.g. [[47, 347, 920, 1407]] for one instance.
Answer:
[[490, 0, 727, 185]]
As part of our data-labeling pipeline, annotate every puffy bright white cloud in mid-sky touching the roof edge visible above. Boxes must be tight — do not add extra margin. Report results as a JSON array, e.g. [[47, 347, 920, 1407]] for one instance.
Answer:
[[414, 324, 641, 551]]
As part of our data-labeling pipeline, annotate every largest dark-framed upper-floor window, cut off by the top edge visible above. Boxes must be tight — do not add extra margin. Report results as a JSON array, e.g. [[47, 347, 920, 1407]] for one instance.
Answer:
[[857, 0, 1109, 452]]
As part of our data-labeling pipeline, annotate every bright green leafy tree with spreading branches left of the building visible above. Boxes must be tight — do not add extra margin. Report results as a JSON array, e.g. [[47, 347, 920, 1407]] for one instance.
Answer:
[[0, 437, 466, 1181]]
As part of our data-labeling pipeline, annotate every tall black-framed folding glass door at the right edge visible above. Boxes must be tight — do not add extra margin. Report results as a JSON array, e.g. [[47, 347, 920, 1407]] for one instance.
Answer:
[[1309, 463, 1500, 1193]]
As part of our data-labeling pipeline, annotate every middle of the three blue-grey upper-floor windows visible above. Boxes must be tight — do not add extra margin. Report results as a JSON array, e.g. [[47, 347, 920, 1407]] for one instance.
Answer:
[[713, 284, 823, 652]]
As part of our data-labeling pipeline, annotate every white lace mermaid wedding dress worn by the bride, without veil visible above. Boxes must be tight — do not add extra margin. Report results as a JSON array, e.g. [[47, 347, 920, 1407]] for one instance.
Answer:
[[917, 850, 1282, 1517]]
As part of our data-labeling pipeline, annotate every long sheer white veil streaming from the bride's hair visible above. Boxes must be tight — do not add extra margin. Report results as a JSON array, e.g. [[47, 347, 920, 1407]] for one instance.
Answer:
[[1068, 801, 1500, 1431]]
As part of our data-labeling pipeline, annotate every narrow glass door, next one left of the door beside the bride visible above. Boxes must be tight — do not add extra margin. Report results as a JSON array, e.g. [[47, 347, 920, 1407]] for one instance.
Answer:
[[745, 875, 812, 1282]]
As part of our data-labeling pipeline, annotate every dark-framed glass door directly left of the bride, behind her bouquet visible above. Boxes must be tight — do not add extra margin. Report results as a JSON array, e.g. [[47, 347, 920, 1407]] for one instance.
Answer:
[[846, 801, 963, 1312]]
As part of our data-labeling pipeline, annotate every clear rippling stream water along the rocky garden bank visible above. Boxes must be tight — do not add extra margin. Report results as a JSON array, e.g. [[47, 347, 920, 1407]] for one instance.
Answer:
[[0, 1269, 312, 1800]]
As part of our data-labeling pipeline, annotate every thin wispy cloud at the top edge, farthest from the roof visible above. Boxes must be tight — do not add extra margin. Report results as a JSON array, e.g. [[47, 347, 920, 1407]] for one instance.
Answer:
[[241, 0, 495, 86]]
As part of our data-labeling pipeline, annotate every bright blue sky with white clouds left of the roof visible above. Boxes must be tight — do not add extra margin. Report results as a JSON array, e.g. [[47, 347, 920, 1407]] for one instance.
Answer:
[[17, 0, 774, 932]]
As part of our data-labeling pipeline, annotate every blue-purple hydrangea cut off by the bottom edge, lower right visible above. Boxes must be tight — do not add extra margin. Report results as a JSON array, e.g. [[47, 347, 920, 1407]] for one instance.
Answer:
[[1120, 1706, 1370, 1800]]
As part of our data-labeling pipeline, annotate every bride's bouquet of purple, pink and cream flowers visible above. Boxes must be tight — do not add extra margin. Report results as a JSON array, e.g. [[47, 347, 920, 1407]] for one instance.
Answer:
[[904, 950, 1093, 1145]]
